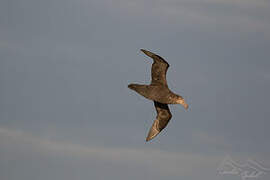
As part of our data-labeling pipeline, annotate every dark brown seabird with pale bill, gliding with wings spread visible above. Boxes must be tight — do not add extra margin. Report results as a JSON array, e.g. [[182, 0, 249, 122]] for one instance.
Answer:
[[128, 49, 188, 141]]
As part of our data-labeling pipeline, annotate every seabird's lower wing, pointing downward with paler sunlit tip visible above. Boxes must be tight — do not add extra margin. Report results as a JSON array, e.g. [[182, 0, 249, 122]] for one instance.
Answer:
[[146, 101, 172, 141]]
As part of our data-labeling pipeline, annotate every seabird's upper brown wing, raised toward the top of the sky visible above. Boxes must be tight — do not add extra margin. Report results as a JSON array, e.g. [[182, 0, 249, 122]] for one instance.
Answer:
[[141, 49, 170, 86]]
